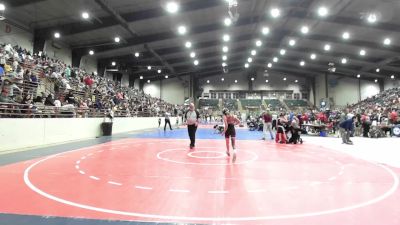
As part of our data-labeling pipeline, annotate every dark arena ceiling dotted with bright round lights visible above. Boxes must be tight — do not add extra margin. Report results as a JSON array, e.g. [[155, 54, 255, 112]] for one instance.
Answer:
[[4, 0, 400, 79]]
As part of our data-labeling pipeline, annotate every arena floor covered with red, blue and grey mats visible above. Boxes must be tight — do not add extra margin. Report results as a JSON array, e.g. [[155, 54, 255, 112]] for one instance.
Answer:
[[0, 128, 400, 225]]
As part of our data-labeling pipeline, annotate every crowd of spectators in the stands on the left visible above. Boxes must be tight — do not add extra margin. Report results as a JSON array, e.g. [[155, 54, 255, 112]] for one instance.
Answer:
[[0, 44, 180, 117]]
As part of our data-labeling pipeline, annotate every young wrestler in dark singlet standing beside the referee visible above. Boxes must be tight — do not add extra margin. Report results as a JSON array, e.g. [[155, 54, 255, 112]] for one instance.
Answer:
[[222, 109, 240, 162]]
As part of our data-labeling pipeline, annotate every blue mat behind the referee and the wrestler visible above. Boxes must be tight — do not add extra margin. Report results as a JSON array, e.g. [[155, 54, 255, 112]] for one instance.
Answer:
[[133, 128, 262, 140]]
